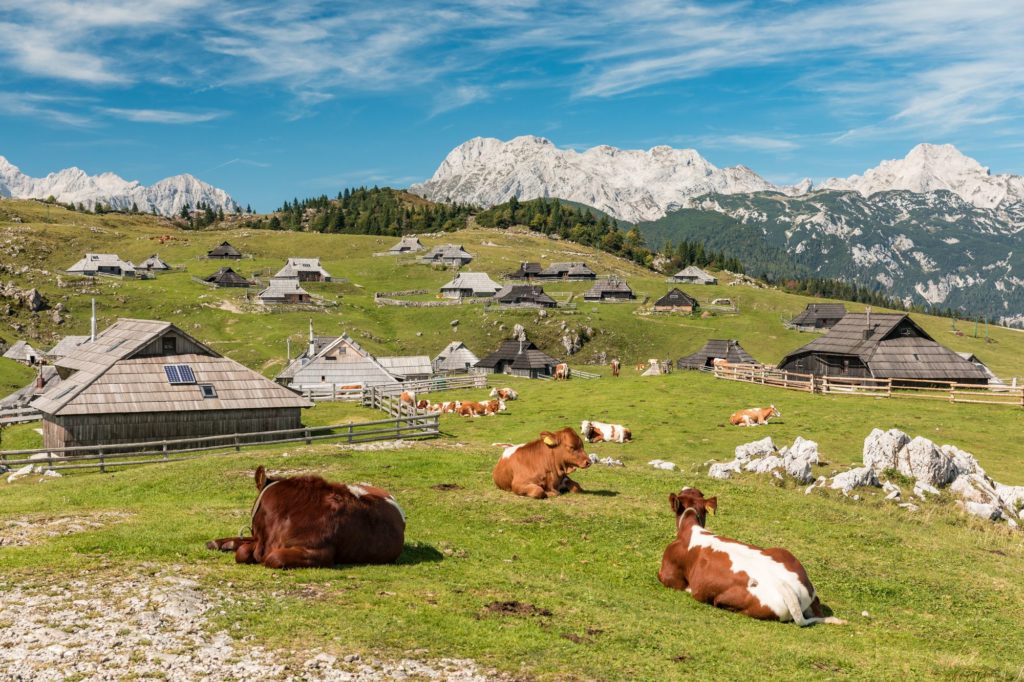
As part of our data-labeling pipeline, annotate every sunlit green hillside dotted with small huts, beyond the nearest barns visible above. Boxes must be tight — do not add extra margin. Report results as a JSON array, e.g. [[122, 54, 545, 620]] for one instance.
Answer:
[[0, 196, 1024, 377]]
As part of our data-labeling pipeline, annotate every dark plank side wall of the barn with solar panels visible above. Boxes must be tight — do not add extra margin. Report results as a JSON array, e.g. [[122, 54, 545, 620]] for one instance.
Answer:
[[43, 408, 302, 447]]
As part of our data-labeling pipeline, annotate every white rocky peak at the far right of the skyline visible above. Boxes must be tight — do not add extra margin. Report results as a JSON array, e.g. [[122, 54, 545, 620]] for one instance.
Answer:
[[818, 144, 1024, 208]]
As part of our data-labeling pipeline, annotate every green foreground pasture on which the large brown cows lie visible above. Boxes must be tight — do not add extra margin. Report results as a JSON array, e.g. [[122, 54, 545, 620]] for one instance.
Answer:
[[0, 373, 1024, 680]]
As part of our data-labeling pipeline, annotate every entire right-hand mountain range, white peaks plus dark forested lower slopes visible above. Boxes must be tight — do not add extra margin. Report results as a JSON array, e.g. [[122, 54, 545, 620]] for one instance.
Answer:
[[410, 137, 1024, 326]]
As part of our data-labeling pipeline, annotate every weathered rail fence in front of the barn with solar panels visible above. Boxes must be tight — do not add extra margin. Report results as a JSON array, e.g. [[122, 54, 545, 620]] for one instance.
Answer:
[[0, 412, 440, 471]]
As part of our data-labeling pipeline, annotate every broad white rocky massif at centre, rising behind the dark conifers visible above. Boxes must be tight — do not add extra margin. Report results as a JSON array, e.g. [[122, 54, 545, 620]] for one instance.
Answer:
[[410, 135, 782, 222]]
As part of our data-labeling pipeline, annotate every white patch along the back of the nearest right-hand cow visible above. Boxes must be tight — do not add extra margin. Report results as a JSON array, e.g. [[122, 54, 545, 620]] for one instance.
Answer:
[[689, 524, 814, 621]]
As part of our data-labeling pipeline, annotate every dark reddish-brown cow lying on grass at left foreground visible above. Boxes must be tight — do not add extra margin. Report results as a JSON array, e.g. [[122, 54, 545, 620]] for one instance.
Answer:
[[206, 467, 406, 568]]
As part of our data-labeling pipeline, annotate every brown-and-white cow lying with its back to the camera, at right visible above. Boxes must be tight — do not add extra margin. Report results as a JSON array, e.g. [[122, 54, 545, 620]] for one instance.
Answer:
[[657, 487, 846, 626]]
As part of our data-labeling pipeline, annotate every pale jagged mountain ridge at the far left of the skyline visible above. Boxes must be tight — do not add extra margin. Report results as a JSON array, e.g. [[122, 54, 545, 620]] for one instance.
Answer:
[[0, 157, 240, 215]]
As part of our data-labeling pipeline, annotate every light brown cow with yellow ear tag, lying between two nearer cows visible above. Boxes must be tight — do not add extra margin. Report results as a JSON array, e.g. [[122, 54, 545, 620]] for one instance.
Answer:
[[493, 426, 590, 500]]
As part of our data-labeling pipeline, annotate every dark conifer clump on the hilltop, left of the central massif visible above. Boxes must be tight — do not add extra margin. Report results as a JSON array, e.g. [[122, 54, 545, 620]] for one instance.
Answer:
[[245, 186, 473, 237]]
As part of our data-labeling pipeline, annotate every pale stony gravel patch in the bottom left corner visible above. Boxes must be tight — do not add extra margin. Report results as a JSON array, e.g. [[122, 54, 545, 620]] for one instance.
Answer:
[[0, 573, 509, 682]]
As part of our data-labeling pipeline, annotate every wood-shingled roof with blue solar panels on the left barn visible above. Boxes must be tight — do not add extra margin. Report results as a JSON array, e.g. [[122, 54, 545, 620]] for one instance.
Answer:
[[32, 319, 311, 416]]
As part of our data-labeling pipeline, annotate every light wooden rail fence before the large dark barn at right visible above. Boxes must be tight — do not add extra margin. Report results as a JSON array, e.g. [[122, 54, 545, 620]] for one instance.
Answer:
[[714, 365, 1024, 408]]
